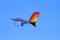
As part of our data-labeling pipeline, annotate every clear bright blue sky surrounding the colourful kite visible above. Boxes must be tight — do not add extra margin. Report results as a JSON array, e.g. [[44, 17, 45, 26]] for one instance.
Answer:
[[0, 0, 60, 40]]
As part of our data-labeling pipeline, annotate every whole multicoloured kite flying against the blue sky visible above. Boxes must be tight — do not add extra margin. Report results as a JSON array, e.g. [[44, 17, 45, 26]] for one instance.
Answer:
[[11, 11, 40, 27]]
